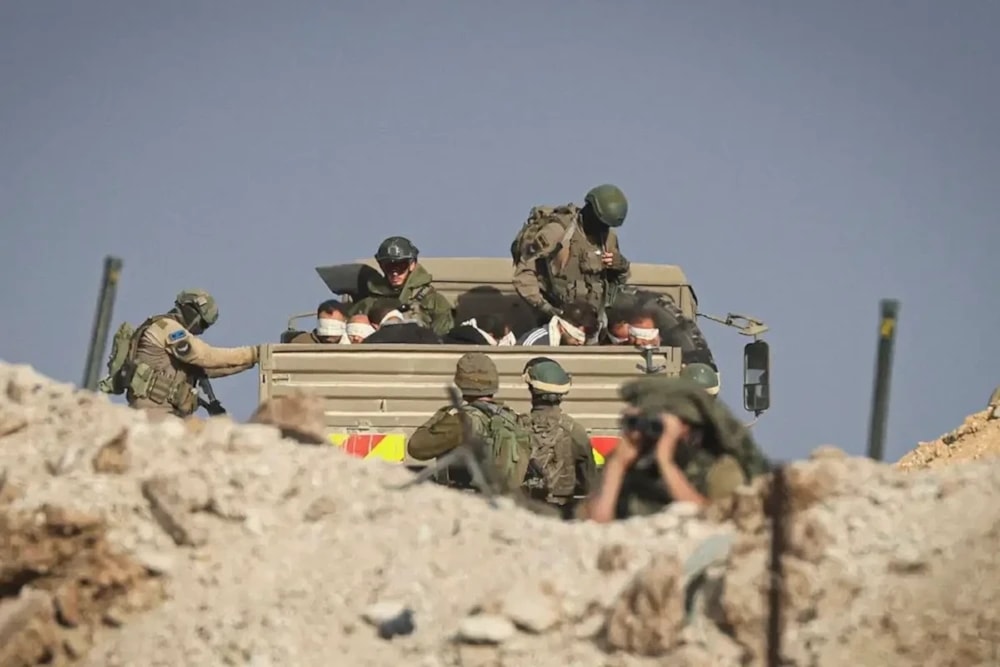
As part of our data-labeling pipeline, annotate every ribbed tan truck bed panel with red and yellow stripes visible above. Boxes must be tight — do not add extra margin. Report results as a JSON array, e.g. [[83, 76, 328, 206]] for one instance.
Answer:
[[258, 344, 680, 466]]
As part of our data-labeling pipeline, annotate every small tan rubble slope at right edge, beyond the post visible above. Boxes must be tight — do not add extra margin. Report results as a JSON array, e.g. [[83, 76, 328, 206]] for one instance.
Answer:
[[896, 406, 1000, 470]]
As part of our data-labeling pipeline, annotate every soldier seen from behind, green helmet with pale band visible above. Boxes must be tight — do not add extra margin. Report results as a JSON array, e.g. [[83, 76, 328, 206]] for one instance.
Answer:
[[522, 357, 597, 508]]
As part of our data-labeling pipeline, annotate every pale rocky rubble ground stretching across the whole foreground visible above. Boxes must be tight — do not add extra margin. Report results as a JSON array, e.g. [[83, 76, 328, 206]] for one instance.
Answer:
[[0, 364, 1000, 667]]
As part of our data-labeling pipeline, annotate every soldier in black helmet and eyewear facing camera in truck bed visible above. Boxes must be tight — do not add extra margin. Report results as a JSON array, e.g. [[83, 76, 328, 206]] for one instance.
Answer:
[[351, 236, 455, 336]]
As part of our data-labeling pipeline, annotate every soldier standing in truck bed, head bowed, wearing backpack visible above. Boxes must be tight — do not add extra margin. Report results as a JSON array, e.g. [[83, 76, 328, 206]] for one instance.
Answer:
[[511, 184, 629, 321]]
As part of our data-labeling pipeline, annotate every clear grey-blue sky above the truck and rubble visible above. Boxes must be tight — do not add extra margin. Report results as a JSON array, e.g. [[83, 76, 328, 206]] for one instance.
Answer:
[[0, 0, 1000, 464]]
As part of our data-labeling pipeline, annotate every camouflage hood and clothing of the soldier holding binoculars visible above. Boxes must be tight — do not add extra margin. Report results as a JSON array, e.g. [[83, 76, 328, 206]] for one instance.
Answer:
[[616, 377, 771, 518]]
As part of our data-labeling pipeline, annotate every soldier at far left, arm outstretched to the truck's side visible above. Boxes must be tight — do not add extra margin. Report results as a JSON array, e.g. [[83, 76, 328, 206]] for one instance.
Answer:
[[124, 289, 259, 417]]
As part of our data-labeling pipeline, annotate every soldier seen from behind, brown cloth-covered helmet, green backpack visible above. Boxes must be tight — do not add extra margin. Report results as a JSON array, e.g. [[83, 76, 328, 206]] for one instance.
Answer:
[[406, 352, 534, 493]]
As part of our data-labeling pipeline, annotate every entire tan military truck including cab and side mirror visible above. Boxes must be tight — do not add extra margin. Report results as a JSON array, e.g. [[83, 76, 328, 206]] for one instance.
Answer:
[[258, 258, 769, 467]]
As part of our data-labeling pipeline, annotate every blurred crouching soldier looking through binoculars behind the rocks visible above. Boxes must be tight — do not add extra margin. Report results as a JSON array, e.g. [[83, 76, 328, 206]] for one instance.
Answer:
[[577, 377, 770, 523]]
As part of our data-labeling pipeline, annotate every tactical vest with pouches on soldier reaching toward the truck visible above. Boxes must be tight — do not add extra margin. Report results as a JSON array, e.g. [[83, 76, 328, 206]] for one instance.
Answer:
[[125, 315, 198, 416]]
